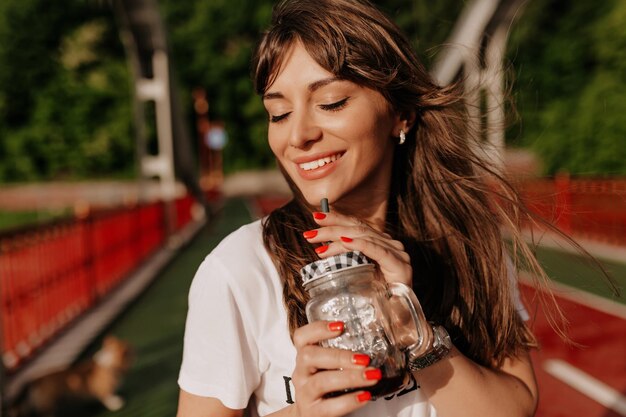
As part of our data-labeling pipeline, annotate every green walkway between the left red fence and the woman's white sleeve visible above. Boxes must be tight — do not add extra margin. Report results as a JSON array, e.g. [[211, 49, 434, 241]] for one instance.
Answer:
[[82, 199, 251, 417]]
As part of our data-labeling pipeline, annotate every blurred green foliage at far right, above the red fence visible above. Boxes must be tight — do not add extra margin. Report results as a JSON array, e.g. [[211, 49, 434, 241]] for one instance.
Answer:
[[511, 0, 626, 175]]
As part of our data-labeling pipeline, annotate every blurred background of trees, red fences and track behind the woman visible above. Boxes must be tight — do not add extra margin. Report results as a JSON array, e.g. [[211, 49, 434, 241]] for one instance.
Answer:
[[0, 0, 626, 417]]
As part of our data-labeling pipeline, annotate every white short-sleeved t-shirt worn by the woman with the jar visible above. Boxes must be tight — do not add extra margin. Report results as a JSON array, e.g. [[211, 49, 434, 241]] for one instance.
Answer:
[[178, 220, 528, 417]]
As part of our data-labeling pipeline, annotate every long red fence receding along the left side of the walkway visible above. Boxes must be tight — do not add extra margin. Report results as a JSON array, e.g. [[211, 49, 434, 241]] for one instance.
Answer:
[[0, 196, 194, 372]]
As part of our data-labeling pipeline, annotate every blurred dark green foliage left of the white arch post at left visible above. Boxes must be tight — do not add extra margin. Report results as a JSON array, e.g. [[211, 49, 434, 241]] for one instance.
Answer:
[[0, 0, 134, 181]]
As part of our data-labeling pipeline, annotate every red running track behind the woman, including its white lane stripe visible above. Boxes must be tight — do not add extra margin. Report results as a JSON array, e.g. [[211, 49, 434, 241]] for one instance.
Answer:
[[251, 197, 626, 417]]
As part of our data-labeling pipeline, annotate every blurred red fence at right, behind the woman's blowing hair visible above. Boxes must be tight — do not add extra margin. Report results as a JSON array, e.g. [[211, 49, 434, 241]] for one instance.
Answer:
[[519, 176, 626, 246]]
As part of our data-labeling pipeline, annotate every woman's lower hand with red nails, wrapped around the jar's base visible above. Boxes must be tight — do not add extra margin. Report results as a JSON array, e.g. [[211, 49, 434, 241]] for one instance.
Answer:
[[292, 321, 382, 417]]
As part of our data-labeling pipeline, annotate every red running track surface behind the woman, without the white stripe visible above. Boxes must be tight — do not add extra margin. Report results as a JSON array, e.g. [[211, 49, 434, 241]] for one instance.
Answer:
[[254, 197, 626, 417]]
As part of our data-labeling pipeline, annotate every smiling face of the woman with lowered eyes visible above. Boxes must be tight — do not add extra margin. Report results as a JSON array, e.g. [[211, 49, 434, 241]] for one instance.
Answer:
[[263, 43, 401, 211]]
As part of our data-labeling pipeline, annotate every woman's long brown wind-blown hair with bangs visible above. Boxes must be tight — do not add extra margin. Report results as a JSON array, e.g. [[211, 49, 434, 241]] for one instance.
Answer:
[[253, 0, 541, 366]]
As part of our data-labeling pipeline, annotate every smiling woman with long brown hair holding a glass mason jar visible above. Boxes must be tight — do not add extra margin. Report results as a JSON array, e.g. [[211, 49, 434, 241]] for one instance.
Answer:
[[179, 0, 537, 417]]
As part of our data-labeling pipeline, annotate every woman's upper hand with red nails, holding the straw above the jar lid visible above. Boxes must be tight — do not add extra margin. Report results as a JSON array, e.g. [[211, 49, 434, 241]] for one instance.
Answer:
[[304, 212, 413, 287]]
